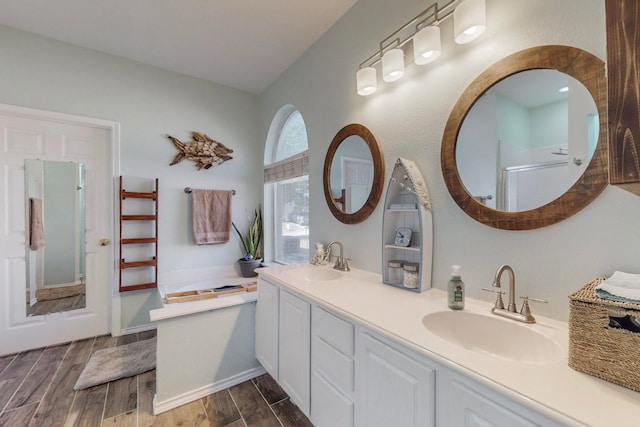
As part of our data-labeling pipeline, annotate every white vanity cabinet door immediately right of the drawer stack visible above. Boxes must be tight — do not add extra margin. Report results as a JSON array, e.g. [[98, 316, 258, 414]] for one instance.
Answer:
[[356, 331, 435, 427]]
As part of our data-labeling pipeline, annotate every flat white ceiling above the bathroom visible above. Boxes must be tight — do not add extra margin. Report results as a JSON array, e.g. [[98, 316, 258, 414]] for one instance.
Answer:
[[0, 0, 357, 94]]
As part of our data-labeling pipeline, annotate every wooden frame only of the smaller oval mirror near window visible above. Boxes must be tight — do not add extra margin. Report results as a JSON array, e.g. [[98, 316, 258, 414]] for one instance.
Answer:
[[322, 124, 384, 224]]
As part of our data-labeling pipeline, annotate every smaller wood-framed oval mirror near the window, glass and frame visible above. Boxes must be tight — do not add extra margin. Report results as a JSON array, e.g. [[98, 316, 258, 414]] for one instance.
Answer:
[[323, 124, 384, 224]]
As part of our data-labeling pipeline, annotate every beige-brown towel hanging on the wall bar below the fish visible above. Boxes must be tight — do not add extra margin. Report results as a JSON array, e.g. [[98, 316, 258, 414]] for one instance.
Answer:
[[191, 190, 233, 245]]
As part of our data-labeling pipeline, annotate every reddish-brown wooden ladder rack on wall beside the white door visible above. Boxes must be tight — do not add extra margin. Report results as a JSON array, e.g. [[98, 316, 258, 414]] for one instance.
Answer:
[[120, 176, 158, 292]]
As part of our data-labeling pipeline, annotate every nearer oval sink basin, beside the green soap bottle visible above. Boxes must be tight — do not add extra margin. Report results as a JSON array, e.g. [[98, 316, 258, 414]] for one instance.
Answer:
[[422, 311, 563, 365]]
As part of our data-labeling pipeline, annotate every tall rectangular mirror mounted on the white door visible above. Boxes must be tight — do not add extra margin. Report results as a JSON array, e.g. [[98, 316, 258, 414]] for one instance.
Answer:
[[25, 160, 86, 316]]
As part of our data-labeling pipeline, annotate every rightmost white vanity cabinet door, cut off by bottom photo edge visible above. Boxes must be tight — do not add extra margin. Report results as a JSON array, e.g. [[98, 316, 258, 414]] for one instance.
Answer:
[[444, 376, 560, 427]]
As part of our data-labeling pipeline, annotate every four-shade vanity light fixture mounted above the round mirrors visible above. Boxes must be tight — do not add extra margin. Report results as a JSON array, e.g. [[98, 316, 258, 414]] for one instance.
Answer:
[[356, 0, 486, 96]]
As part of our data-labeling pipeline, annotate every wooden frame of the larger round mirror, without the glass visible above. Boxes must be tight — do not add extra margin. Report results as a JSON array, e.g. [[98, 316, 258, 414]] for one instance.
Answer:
[[440, 46, 608, 230]]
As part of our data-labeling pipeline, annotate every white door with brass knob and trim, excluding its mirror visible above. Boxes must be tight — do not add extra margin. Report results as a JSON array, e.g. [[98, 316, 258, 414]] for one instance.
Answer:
[[0, 105, 118, 355]]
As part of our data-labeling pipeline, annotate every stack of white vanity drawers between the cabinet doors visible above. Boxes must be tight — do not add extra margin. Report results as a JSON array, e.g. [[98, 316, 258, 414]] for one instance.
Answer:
[[311, 305, 355, 427]]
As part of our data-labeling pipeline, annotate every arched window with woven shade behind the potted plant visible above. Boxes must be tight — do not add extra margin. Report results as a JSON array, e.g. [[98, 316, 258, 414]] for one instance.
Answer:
[[264, 105, 309, 264]]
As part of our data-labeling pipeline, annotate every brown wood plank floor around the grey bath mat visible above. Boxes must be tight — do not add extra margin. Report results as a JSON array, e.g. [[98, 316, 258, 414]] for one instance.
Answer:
[[0, 331, 312, 427]]
